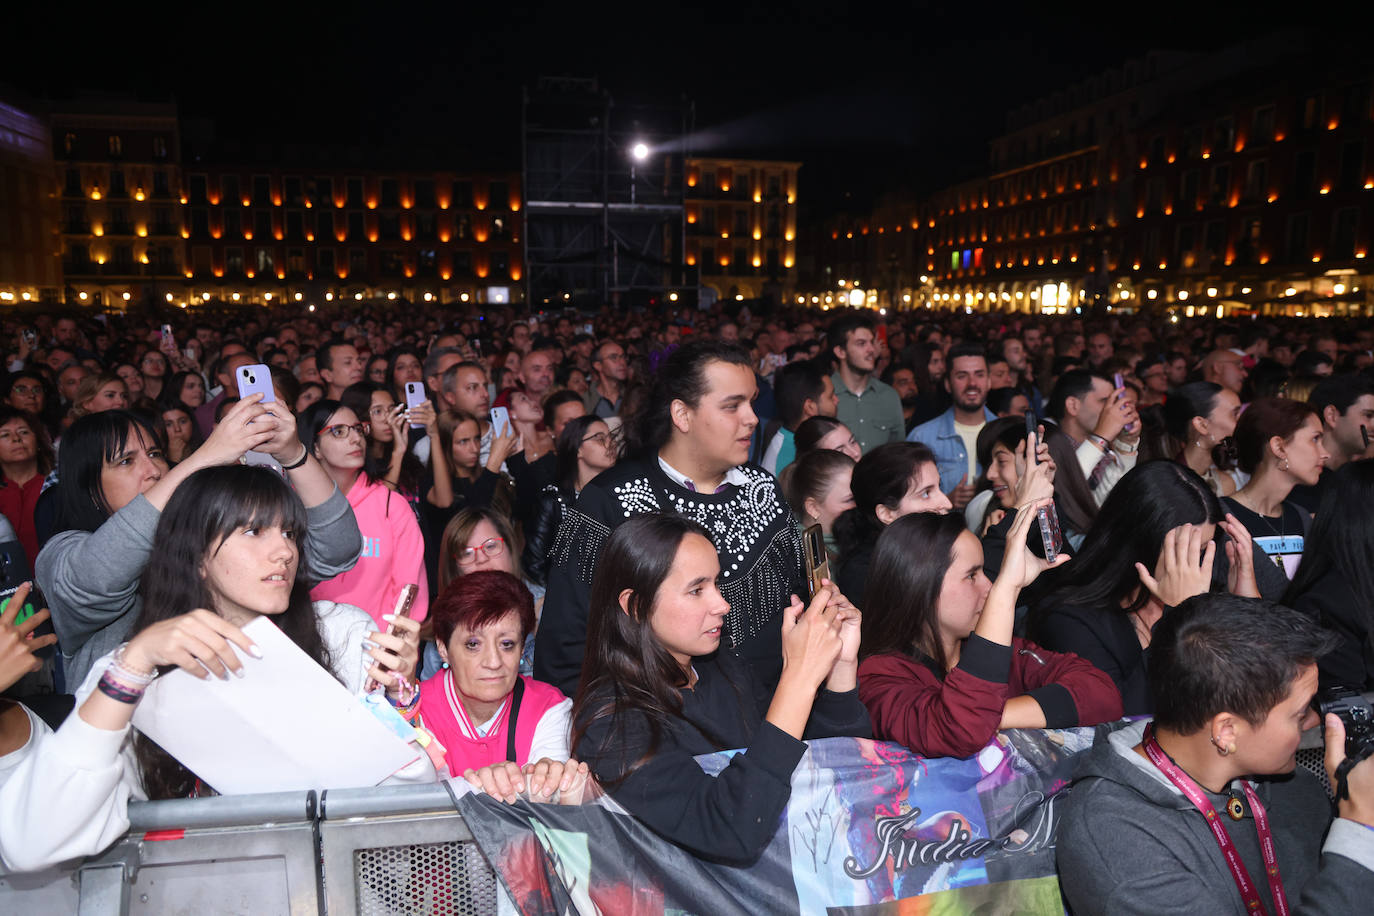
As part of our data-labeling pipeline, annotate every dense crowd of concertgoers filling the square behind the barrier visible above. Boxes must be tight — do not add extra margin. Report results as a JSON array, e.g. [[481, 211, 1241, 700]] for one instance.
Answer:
[[0, 302, 1374, 913]]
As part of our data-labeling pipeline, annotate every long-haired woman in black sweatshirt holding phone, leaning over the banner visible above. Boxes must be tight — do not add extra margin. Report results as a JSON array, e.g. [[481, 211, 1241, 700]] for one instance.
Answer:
[[572, 514, 871, 864]]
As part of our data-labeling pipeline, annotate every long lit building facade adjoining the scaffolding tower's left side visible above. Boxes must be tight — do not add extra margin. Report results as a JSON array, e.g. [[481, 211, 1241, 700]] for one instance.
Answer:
[[183, 166, 522, 302]]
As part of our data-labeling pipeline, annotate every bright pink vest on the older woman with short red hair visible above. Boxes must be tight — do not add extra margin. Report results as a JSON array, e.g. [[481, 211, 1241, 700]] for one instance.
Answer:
[[420, 669, 563, 776]]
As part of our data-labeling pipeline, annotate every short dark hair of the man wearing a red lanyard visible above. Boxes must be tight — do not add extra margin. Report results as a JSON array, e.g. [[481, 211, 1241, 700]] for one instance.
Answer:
[[1149, 592, 1338, 735]]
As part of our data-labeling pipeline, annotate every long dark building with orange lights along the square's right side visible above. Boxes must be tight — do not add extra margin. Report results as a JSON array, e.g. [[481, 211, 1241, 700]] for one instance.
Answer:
[[831, 36, 1374, 316]]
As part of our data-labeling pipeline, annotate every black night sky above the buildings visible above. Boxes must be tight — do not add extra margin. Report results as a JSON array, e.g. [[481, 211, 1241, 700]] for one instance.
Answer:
[[0, 0, 1283, 210]]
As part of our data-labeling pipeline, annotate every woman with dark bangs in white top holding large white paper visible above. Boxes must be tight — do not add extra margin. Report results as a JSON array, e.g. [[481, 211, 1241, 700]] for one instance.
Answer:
[[0, 464, 436, 868]]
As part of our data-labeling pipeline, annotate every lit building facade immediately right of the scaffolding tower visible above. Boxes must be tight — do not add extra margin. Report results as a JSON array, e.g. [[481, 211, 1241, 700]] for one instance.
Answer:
[[686, 158, 801, 299]]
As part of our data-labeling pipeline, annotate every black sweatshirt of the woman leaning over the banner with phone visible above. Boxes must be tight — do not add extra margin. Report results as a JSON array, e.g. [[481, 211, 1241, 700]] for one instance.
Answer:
[[571, 650, 872, 864]]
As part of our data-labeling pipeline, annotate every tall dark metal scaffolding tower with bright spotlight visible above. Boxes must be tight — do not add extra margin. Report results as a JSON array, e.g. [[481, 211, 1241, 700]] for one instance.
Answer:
[[521, 78, 695, 309]]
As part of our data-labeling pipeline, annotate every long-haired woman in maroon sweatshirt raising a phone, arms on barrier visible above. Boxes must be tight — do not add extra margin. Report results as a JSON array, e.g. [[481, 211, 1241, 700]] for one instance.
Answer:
[[859, 502, 1121, 757]]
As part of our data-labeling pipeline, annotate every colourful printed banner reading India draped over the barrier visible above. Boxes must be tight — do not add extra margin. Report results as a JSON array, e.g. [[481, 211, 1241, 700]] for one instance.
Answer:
[[459, 726, 1107, 916]]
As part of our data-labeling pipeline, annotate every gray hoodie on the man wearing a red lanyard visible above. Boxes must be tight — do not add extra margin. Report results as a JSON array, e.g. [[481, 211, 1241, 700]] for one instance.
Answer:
[[1057, 721, 1374, 916]]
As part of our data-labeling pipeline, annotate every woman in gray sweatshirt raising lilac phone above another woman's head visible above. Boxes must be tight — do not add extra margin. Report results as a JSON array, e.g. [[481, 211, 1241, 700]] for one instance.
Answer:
[[34, 394, 360, 685]]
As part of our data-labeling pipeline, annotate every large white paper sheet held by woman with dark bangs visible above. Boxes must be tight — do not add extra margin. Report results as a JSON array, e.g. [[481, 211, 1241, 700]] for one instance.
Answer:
[[133, 617, 423, 795]]
